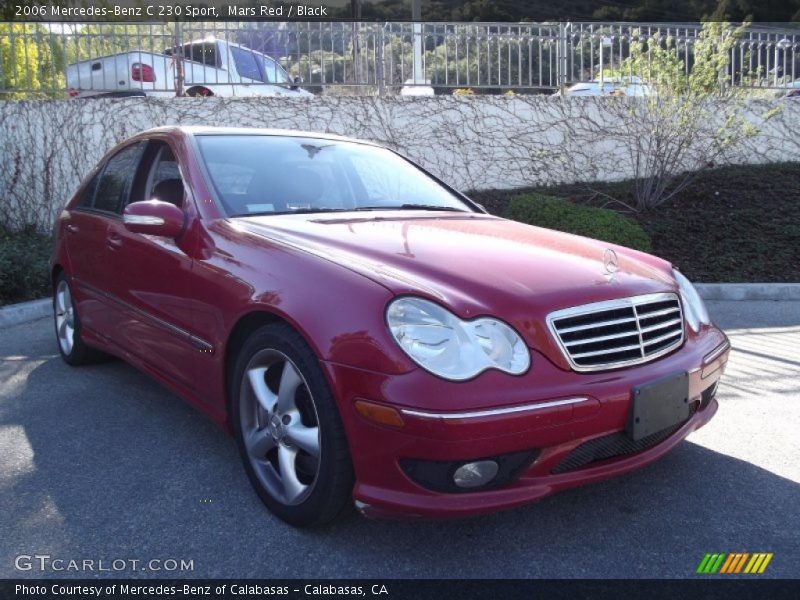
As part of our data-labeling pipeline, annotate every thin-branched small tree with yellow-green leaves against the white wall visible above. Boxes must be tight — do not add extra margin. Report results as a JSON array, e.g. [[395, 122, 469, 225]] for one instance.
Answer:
[[609, 23, 774, 211]]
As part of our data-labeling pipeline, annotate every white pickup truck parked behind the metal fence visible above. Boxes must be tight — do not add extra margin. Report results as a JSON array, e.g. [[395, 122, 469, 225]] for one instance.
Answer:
[[67, 38, 312, 98]]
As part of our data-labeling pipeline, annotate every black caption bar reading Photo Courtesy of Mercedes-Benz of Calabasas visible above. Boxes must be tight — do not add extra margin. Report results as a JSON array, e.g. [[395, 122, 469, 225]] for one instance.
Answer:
[[0, 575, 800, 600]]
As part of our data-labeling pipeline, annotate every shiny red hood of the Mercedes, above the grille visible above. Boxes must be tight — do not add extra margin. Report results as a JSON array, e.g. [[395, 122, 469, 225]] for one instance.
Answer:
[[236, 211, 677, 368]]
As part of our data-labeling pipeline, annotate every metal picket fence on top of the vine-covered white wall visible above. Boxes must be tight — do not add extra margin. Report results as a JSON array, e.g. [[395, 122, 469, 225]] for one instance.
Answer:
[[0, 22, 800, 98]]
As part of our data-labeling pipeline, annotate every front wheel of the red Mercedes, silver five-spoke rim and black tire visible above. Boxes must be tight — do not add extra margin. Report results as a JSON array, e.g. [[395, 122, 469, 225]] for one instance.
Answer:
[[230, 323, 355, 527]]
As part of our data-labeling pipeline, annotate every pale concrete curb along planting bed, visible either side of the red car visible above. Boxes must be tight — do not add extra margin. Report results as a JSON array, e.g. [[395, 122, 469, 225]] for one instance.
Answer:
[[0, 283, 800, 328]]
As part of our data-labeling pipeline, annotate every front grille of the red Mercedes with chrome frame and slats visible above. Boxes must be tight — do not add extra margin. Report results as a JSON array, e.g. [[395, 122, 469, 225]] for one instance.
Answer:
[[547, 294, 683, 371]]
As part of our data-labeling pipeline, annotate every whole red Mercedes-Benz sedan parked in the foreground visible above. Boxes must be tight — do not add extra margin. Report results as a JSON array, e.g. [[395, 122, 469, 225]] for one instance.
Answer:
[[52, 127, 730, 525]]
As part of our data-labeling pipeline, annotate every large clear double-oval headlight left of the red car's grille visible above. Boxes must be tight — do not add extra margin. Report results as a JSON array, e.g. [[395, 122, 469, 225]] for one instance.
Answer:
[[386, 296, 531, 381]]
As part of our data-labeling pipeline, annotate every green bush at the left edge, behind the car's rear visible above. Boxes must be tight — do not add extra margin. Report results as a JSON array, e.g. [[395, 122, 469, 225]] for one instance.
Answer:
[[0, 227, 52, 306]]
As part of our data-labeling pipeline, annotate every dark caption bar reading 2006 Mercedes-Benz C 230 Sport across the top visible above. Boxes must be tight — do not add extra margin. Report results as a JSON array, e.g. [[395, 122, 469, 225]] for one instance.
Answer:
[[9, 0, 797, 26]]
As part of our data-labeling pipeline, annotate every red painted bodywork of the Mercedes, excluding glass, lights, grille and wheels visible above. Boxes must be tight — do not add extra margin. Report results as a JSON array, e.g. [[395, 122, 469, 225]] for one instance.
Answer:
[[52, 128, 728, 517]]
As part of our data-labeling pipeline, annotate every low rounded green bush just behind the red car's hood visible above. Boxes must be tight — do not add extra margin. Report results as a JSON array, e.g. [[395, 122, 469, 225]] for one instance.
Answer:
[[506, 194, 651, 252]]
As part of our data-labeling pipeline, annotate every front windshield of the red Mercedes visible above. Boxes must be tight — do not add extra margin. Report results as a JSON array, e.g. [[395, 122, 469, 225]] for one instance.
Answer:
[[197, 135, 473, 216]]
